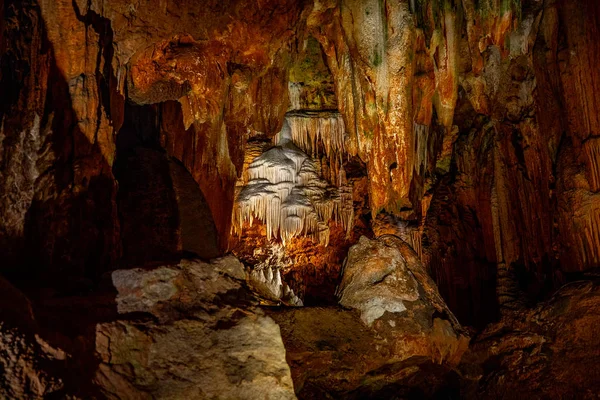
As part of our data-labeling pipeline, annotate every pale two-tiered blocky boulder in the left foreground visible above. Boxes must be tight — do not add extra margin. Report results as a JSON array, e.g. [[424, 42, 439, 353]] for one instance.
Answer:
[[95, 257, 296, 399]]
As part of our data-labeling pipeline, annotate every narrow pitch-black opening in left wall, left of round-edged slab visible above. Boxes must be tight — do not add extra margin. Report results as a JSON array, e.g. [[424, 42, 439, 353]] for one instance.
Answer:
[[113, 103, 179, 265]]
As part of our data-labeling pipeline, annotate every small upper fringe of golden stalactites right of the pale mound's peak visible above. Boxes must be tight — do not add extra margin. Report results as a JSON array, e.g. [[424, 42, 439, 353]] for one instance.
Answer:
[[275, 111, 346, 158]]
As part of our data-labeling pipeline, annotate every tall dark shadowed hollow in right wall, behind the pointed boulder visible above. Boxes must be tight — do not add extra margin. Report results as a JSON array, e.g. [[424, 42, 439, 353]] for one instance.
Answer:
[[422, 95, 499, 328]]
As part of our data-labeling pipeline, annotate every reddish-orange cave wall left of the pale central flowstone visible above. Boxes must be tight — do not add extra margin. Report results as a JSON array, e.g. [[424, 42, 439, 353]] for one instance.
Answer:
[[0, 0, 303, 279]]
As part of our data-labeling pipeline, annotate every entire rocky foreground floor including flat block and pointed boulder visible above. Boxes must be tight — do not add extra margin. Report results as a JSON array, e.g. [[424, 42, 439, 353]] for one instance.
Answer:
[[0, 236, 600, 399]]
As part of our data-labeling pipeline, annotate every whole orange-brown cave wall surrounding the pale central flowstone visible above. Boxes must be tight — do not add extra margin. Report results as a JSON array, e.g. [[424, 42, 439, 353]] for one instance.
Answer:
[[0, 0, 600, 322]]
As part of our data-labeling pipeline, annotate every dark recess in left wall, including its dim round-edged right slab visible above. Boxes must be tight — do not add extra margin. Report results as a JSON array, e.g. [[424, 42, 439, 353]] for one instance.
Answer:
[[113, 103, 220, 266]]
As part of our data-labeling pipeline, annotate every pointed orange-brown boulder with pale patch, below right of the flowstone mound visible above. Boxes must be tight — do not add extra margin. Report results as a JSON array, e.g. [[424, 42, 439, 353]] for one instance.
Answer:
[[338, 235, 468, 364]]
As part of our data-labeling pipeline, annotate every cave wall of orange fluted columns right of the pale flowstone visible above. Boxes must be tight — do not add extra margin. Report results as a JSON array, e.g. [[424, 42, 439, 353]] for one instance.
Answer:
[[307, 0, 600, 323]]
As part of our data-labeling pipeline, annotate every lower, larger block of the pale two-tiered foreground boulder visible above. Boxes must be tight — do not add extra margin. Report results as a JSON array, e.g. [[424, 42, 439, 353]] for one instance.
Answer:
[[96, 315, 296, 399]]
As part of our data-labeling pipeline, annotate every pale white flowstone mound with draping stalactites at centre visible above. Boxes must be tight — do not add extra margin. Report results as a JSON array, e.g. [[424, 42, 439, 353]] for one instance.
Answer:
[[232, 125, 354, 246]]
